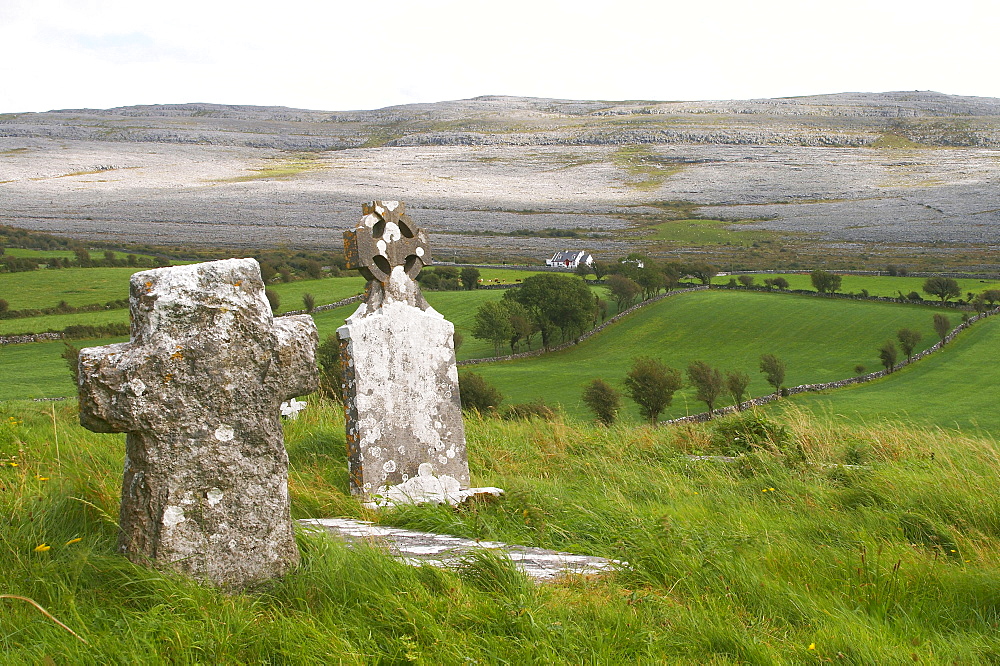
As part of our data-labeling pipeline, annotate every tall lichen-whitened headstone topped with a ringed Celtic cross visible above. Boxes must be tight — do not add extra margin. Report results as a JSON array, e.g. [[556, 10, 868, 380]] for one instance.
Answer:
[[337, 201, 469, 501]]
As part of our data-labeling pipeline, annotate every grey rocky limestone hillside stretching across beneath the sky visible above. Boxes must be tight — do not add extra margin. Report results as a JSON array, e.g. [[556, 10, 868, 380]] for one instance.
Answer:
[[0, 92, 1000, 268]]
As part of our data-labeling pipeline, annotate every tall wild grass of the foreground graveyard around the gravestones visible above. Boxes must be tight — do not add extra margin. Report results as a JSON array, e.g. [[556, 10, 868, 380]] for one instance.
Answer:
[[0, 398, 1000, 664]]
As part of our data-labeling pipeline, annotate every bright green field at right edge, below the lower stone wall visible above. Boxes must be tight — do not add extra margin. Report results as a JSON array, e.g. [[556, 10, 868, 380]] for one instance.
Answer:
[[789, 316, 1000, 436]]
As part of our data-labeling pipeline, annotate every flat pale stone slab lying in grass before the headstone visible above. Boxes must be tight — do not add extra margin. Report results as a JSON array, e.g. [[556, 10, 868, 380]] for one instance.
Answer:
[[299, 518, 623, 581]]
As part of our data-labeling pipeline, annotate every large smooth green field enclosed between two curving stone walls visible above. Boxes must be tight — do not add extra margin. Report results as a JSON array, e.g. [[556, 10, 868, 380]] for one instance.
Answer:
[[469, 290, 958, 420]]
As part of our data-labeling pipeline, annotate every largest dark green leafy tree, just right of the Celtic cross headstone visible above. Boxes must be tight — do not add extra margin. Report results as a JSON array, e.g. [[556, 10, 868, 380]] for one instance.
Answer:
[[503, 273, 595, 349]]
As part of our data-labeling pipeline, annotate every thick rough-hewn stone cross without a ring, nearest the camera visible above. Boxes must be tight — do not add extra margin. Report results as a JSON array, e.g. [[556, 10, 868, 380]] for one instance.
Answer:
[[80, 259, 318, 588]]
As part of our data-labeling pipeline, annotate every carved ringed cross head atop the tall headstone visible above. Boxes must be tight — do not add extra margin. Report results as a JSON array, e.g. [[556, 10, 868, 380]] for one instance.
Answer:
[[344, 201, 431, 284]]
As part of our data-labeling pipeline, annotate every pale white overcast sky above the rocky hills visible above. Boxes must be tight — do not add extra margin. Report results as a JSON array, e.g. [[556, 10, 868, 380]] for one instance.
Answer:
[[0, 0, 1000, 112]]
